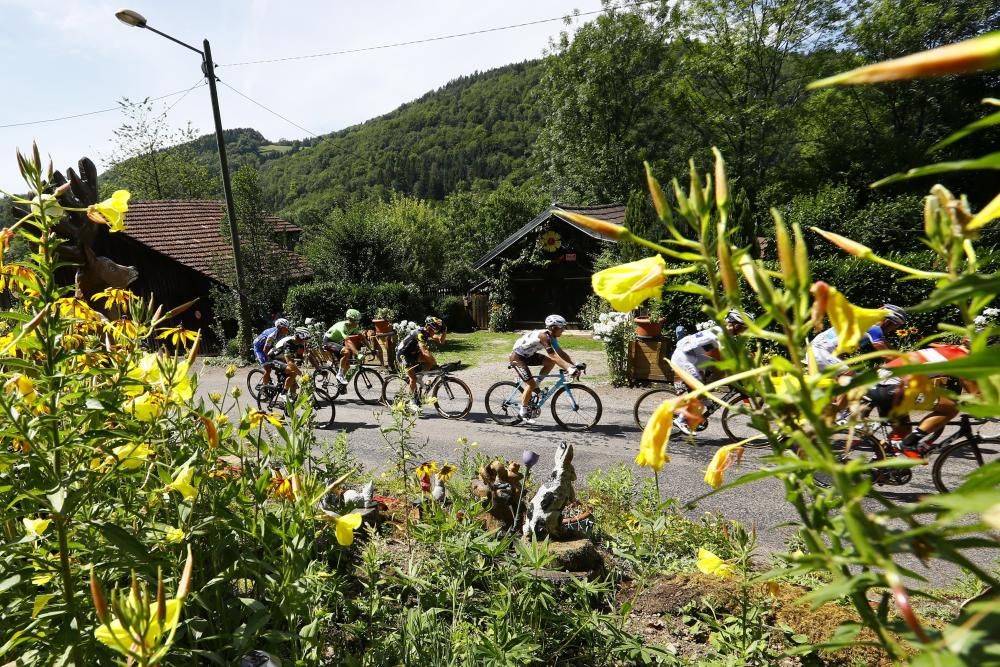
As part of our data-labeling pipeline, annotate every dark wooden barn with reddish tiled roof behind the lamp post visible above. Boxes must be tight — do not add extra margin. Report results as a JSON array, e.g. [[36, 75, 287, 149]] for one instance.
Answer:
[[96, 200, 312, 345]]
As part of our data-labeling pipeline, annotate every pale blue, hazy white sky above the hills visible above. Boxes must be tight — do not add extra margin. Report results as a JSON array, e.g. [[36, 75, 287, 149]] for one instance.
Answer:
[[0, 0, 601, 192]]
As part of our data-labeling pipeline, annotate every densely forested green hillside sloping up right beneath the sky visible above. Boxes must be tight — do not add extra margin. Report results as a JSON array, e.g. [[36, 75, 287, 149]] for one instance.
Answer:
[[264, 61, 542, 222]]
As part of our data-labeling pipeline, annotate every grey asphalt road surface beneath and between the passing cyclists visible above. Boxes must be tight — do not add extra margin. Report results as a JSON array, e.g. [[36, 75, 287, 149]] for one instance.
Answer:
[[199, 352, 992, 585]]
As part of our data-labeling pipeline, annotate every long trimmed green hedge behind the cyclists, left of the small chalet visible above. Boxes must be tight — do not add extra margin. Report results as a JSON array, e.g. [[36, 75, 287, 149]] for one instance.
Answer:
[[285, 281, 425, 322]]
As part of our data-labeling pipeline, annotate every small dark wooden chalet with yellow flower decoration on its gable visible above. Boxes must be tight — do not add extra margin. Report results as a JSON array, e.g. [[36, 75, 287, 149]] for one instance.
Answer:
[[470, 204, 625, 329]]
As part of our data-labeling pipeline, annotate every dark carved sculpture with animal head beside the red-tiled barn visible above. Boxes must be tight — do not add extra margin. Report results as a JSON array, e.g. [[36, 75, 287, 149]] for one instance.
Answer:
[[26, 158, 139, 308]]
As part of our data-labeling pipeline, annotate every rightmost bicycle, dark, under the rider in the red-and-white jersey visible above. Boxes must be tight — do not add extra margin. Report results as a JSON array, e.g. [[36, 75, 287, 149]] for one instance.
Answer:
[[813, 414, 1000, 493]]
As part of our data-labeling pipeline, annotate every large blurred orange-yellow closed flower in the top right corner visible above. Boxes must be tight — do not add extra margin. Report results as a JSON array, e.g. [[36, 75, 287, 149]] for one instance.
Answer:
[[809, 31, 1000, 88]]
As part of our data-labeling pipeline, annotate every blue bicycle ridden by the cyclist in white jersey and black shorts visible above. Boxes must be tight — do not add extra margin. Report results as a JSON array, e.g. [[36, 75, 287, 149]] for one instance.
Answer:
[[486, 364, 603, 431]]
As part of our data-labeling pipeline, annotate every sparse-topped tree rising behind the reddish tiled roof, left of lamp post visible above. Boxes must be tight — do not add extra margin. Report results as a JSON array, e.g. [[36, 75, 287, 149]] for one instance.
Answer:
[[102, 97, 220, 199]]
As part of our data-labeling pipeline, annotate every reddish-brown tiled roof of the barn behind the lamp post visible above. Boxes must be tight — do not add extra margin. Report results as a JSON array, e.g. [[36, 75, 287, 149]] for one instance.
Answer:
[[124, 199, 312, 283]]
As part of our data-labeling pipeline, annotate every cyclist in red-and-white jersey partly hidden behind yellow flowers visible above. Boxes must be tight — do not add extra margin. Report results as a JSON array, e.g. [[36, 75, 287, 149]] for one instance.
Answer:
[[865, 345, 979, 458]]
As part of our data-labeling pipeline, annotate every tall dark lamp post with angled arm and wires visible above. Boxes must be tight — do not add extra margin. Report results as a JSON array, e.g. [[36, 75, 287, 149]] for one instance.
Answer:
[[115, 9, 250, 357]]
